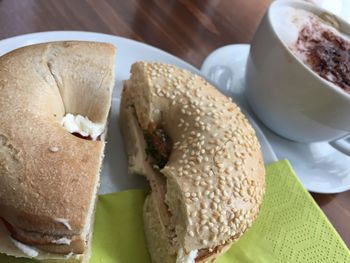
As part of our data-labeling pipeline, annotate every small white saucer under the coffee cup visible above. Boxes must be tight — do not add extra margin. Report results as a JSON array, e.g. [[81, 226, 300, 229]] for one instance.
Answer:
[[201, 45, 350, 193]]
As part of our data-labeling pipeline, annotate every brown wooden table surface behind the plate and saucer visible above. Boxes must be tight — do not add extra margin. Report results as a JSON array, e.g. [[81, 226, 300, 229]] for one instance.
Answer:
[[0, 0, 350, 250]]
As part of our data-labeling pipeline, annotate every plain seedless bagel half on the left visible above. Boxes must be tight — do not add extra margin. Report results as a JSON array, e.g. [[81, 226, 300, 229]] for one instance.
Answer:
[[0, 42, 115, 262]]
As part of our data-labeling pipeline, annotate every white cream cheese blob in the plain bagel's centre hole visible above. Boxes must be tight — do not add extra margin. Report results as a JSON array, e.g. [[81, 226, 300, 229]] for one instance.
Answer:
[[61, 113, 104, 141]]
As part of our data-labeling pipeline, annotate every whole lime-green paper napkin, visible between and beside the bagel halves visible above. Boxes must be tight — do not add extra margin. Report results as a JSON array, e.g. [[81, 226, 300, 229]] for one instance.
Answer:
[[0, 161, 350, 263]]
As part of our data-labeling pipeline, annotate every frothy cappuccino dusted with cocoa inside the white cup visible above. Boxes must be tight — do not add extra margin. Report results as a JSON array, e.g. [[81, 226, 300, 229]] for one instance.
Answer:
[[272, 7, 350, 94]]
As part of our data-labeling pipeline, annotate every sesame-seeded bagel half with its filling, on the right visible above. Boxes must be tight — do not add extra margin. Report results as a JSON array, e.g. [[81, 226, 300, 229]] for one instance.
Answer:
[[120, 62, 265, 263]]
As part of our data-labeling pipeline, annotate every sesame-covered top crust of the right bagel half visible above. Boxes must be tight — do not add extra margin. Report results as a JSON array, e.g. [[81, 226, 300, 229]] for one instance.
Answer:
[[122, 62, 265, 251]]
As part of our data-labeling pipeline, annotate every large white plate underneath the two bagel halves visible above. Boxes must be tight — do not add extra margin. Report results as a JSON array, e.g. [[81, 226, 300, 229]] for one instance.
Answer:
[[0, 31, 277, 194]]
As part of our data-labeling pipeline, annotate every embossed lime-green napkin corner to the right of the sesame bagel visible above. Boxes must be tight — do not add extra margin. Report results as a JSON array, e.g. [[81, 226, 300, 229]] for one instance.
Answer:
[[218, 161, 350, 263]]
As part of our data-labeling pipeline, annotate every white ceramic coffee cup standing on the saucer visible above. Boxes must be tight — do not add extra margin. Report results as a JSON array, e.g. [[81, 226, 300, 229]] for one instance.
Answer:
[[246, 0, 350, 154]]
